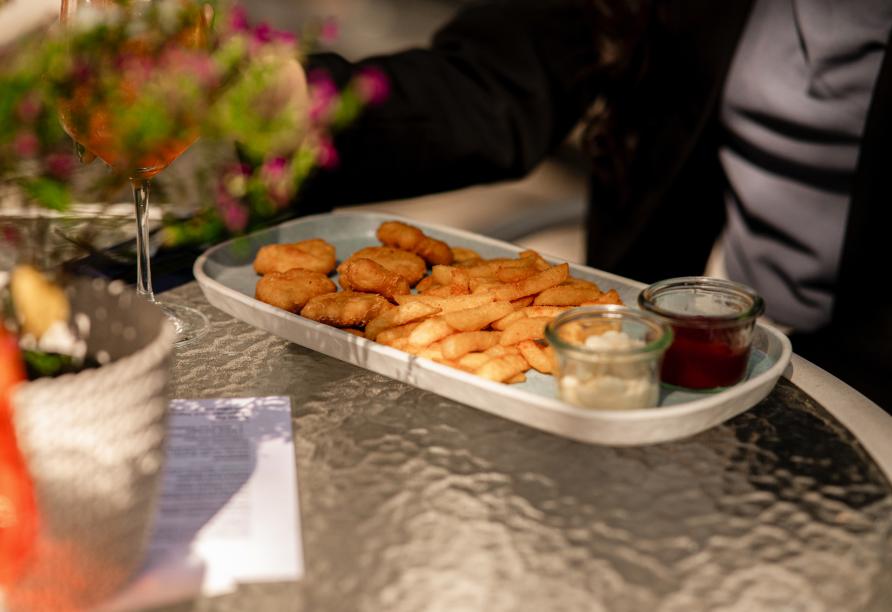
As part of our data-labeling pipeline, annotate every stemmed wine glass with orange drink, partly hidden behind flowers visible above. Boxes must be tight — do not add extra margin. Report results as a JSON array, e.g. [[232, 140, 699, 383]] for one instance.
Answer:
[[59, 0, 213, 347]]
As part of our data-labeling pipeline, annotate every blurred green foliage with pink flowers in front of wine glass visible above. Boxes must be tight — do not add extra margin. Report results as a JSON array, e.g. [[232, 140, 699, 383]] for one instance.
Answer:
[[0, 0, 380, 251]]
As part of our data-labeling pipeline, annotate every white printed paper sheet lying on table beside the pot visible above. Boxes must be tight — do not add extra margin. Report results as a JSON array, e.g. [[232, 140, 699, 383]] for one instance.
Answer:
[[100, 397, 303, 610]]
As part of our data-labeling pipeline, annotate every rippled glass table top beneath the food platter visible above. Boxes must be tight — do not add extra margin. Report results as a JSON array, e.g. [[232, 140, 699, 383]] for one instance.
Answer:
[[165, 283, 892, 612]]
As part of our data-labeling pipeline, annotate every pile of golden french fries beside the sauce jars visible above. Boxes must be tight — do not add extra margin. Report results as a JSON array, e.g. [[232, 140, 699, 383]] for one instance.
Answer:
[[363, 247, 622, 384]]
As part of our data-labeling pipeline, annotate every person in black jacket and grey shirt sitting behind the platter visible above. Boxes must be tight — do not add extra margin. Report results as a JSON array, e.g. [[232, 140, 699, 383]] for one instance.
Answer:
[[296, 0, 892, 411]]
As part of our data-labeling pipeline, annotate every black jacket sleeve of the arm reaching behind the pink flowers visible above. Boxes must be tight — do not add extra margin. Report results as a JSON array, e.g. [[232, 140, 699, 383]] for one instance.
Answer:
[[297, 0, 624, 213]]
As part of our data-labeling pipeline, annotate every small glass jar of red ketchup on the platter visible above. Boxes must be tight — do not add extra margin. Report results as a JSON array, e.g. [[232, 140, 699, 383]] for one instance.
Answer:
[[638, 276, 765, 390]]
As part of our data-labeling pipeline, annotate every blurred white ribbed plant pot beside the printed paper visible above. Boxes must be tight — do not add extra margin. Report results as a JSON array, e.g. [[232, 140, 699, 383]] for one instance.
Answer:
[[7, 279, 174, 609]]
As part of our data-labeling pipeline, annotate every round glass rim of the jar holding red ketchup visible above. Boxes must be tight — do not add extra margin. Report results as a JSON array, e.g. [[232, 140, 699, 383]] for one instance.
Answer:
[[638, 276, 765, 326]]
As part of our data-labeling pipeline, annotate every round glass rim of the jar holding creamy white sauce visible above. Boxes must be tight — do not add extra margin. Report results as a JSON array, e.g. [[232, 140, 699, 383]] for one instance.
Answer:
[[545, 304, 674, 358]]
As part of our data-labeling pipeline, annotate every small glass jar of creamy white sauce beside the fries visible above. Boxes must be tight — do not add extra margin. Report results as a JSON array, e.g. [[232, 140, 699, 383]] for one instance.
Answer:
[[545, 305, 672, 410]]
